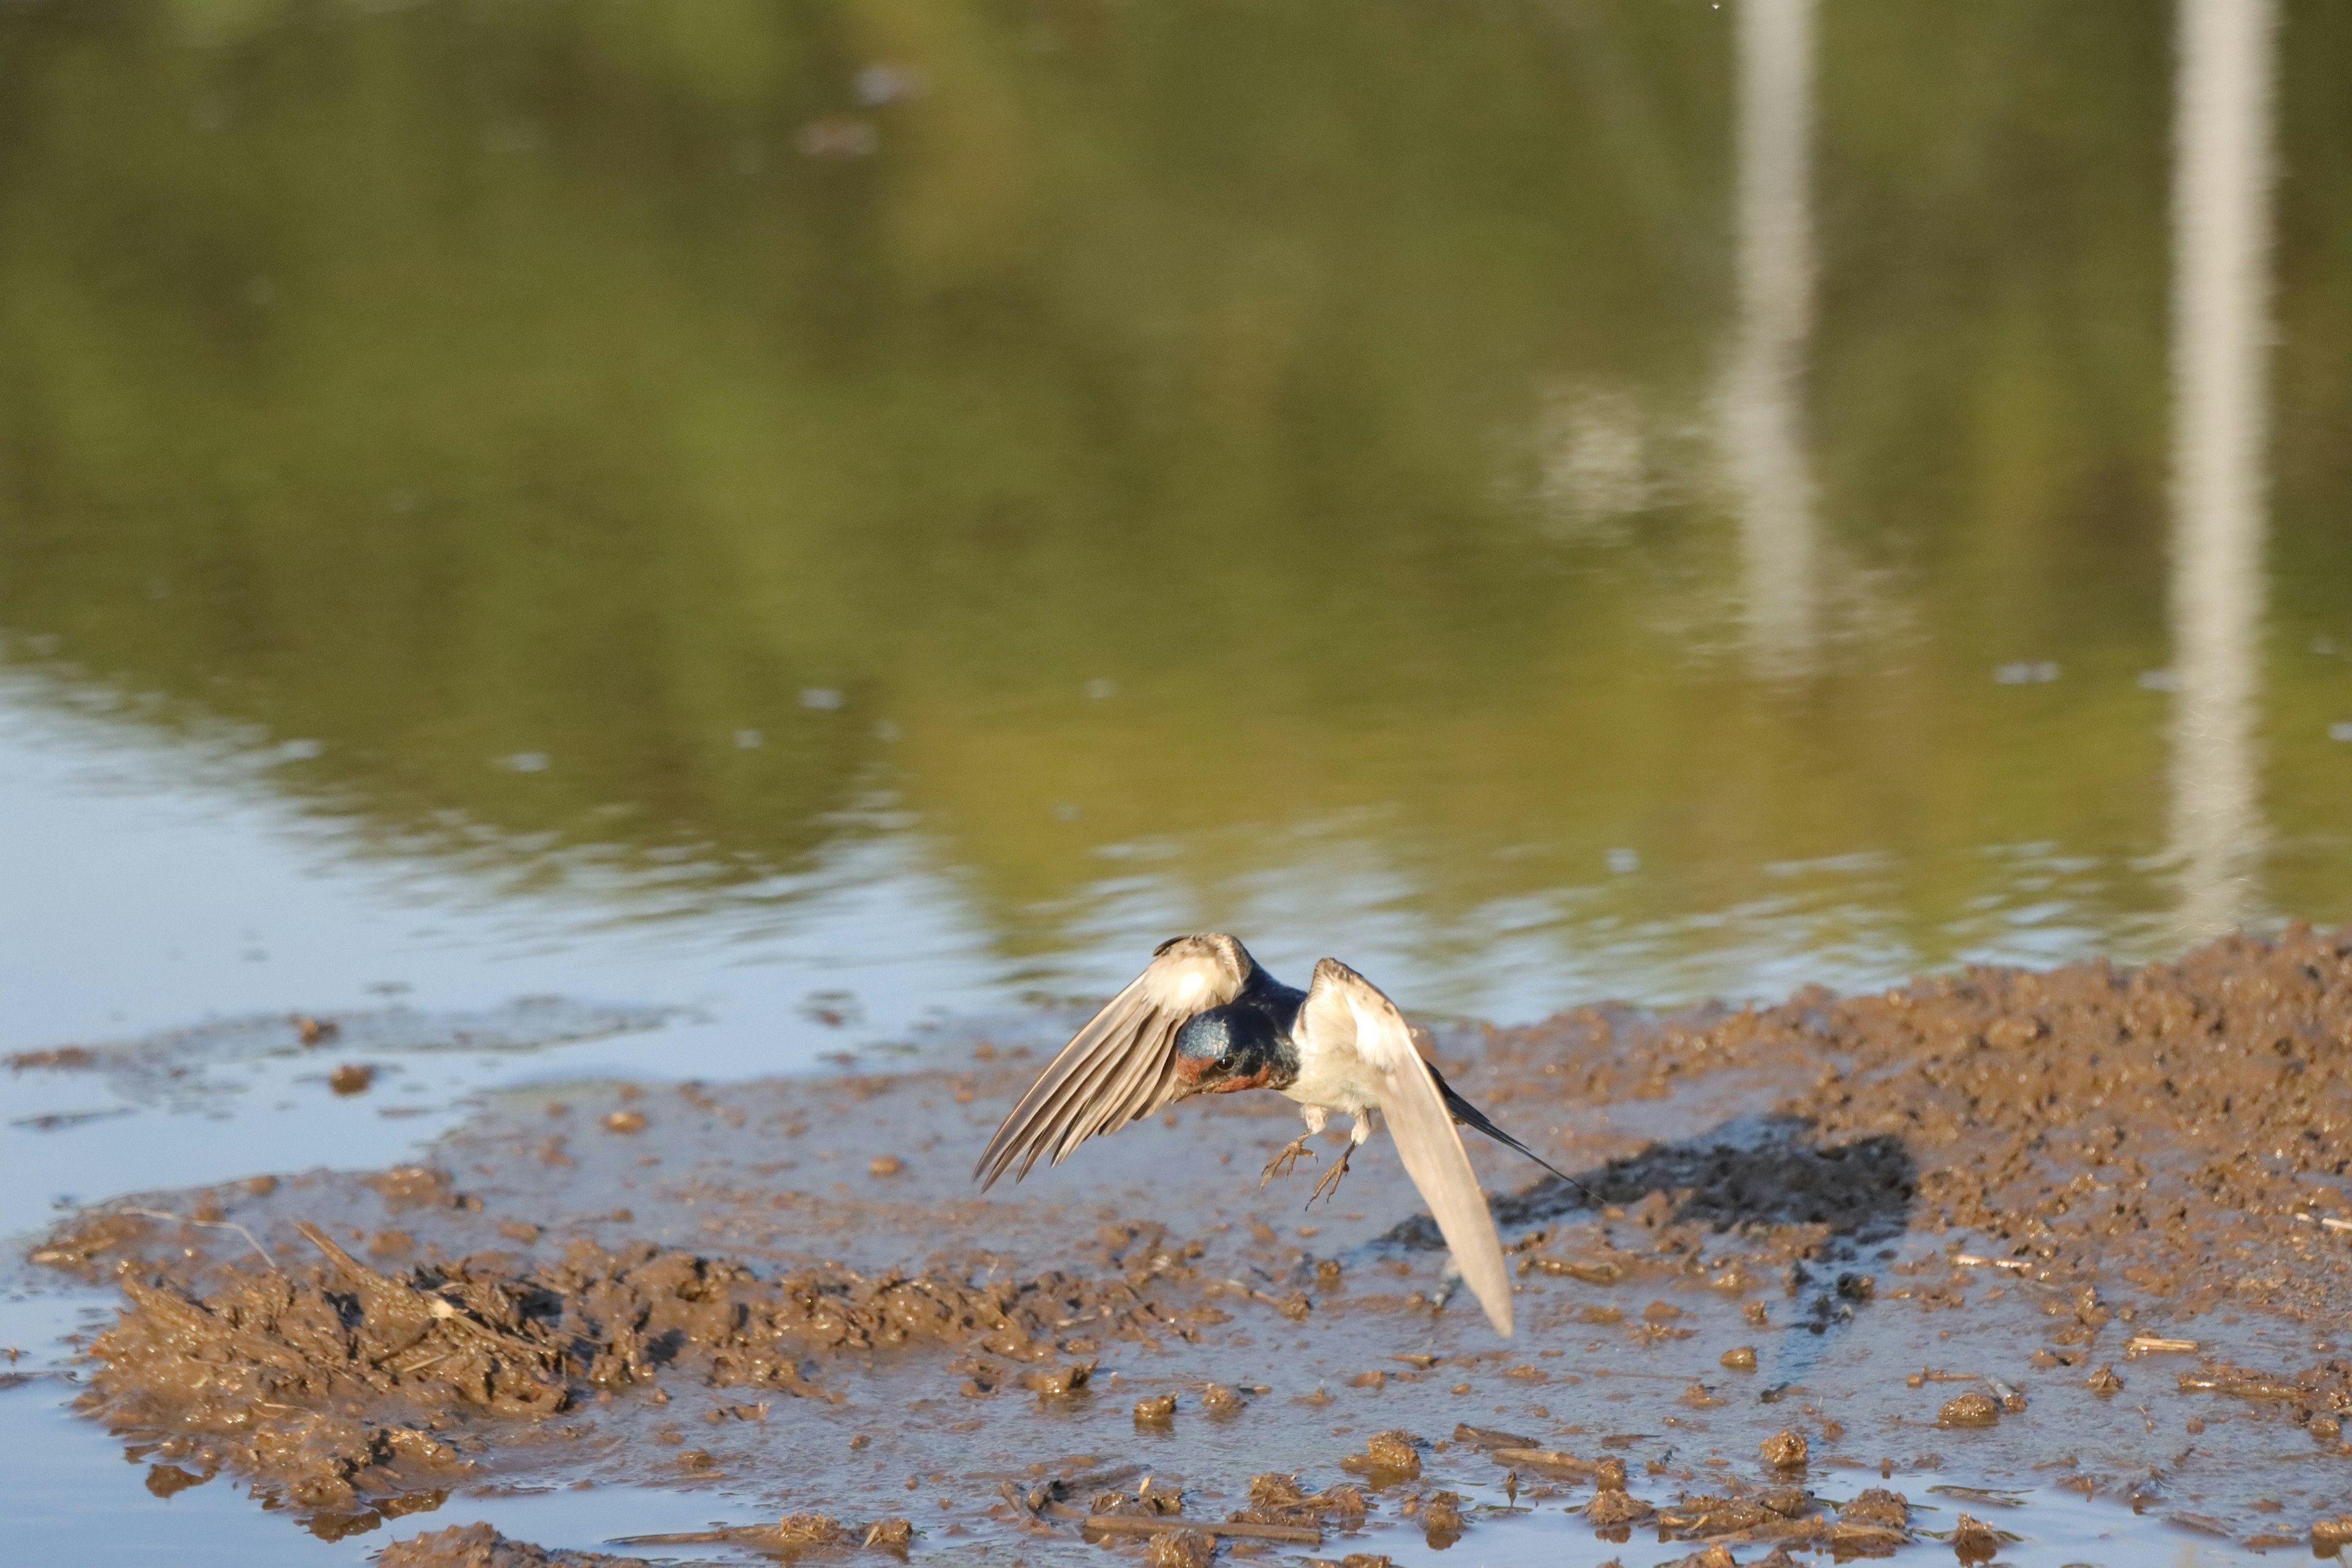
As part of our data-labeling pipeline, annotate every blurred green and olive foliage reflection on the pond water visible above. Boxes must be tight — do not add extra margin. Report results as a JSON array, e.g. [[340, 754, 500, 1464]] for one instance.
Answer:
[[0, 0, 2352, 1001]]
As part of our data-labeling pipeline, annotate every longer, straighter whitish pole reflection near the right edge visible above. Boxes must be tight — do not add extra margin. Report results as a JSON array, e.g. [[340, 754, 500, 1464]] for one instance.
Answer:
[[2171, 0, 2277, 938]]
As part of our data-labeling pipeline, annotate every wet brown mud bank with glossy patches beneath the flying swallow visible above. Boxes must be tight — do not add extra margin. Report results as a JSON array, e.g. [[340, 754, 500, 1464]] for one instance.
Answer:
[[31, 931, 2352, 1568]]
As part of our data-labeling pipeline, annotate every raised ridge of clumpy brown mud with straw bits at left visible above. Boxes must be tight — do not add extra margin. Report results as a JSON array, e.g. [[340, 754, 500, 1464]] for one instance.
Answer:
[[62, 1213, 1204, 1532]]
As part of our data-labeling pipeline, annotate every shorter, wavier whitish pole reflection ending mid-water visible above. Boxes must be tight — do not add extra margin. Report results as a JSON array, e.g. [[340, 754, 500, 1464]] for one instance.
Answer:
[[1724, 0, 1818, 673]]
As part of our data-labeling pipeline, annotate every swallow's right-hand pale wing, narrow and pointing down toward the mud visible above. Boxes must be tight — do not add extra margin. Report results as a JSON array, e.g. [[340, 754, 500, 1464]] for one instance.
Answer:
[[1298, 959, 1510, 1340]]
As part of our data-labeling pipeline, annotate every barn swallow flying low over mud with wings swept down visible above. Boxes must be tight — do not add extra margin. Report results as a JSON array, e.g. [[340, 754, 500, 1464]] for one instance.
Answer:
[[971, 931, 1574, 1340]]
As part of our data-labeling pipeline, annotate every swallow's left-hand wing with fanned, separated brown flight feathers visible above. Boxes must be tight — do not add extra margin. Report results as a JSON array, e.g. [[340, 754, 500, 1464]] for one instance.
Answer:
[[971, 931, 1256, 1189]]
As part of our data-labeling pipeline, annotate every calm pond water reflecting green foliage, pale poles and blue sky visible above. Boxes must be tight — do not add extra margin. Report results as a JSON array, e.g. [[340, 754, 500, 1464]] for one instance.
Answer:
[[0, 0, 2352, 1563]]
